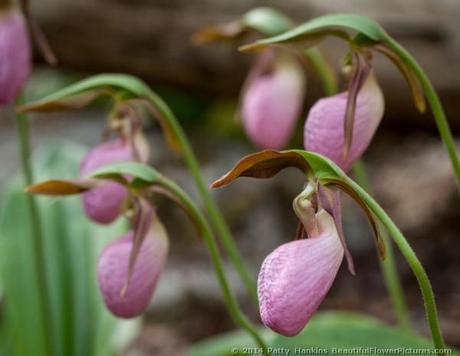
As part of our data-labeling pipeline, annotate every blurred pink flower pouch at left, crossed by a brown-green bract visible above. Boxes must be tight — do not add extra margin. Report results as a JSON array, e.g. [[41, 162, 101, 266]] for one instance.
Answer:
[[80, 139, 134, 224]]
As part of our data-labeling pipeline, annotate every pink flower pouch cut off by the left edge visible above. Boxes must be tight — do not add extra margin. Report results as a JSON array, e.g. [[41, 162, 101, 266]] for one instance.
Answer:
[[0, 9, 31, 105]]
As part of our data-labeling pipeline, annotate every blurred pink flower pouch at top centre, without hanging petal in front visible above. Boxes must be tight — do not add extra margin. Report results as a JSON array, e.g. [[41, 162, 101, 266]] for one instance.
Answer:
[[241, 51, 305, 149]]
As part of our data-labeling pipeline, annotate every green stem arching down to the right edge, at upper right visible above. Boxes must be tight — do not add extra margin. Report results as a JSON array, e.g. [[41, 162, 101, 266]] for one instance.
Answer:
[[385, 36, 460, 189]]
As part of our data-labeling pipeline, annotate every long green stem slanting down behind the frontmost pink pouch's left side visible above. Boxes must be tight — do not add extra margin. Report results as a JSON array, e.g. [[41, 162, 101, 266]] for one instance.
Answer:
[[143, 90, 258, 305]]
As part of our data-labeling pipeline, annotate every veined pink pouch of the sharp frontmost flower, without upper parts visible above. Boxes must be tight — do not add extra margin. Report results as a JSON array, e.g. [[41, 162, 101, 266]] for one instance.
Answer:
[[257, 210, 344, 336]]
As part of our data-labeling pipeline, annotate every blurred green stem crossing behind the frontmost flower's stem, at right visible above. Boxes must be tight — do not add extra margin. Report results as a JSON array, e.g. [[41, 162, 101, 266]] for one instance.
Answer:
[[352, 160, 411, 331]]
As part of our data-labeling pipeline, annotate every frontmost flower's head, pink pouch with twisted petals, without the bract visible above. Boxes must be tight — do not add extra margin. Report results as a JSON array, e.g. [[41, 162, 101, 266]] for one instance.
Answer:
[[257, 184, 354, 336]]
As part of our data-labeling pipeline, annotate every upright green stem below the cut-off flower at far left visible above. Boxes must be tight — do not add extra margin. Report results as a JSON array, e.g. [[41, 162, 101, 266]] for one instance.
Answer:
[[16, 95, 52, 355]]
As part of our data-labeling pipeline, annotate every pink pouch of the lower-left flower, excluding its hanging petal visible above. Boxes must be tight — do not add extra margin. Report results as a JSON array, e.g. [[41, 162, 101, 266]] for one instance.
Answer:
[[97, 231, 169, 318]]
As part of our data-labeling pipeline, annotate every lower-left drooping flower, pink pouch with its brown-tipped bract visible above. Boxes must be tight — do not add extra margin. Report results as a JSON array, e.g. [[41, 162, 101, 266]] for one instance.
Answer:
[[28, 156, 175, 318]]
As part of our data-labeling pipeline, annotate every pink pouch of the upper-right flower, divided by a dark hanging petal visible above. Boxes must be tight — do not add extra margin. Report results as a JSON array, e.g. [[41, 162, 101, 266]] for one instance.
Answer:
[[304, 74, 384, 171]]
